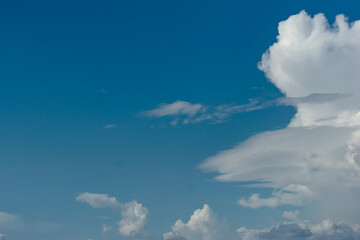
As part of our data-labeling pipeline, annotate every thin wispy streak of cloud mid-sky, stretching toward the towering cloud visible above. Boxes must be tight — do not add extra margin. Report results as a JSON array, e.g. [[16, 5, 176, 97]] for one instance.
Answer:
[[143, 99, 262, 126]]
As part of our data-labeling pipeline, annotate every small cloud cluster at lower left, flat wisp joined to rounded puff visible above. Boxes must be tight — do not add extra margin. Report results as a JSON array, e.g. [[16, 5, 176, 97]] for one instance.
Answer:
[[75, 192, 149, 238]]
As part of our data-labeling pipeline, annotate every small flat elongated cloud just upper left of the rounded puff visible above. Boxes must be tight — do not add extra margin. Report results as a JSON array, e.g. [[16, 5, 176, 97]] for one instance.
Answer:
[[75, 192, 120, 208]]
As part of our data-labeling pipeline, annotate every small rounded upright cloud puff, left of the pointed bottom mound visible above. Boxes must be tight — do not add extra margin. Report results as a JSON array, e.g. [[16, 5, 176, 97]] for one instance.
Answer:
[[118, 201, 149, 237]]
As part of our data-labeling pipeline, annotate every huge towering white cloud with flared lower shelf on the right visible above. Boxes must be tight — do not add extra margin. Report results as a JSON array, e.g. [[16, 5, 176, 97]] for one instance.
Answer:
[[200, 11, 360, 221]]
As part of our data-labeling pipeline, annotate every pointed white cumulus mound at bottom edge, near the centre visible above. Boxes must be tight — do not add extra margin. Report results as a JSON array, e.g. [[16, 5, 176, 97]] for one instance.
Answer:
[[163, 204, 236, 240]]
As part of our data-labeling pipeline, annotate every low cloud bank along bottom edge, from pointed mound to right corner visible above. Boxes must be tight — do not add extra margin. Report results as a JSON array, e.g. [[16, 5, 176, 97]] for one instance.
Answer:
[[163, 204, 360, 240]]
